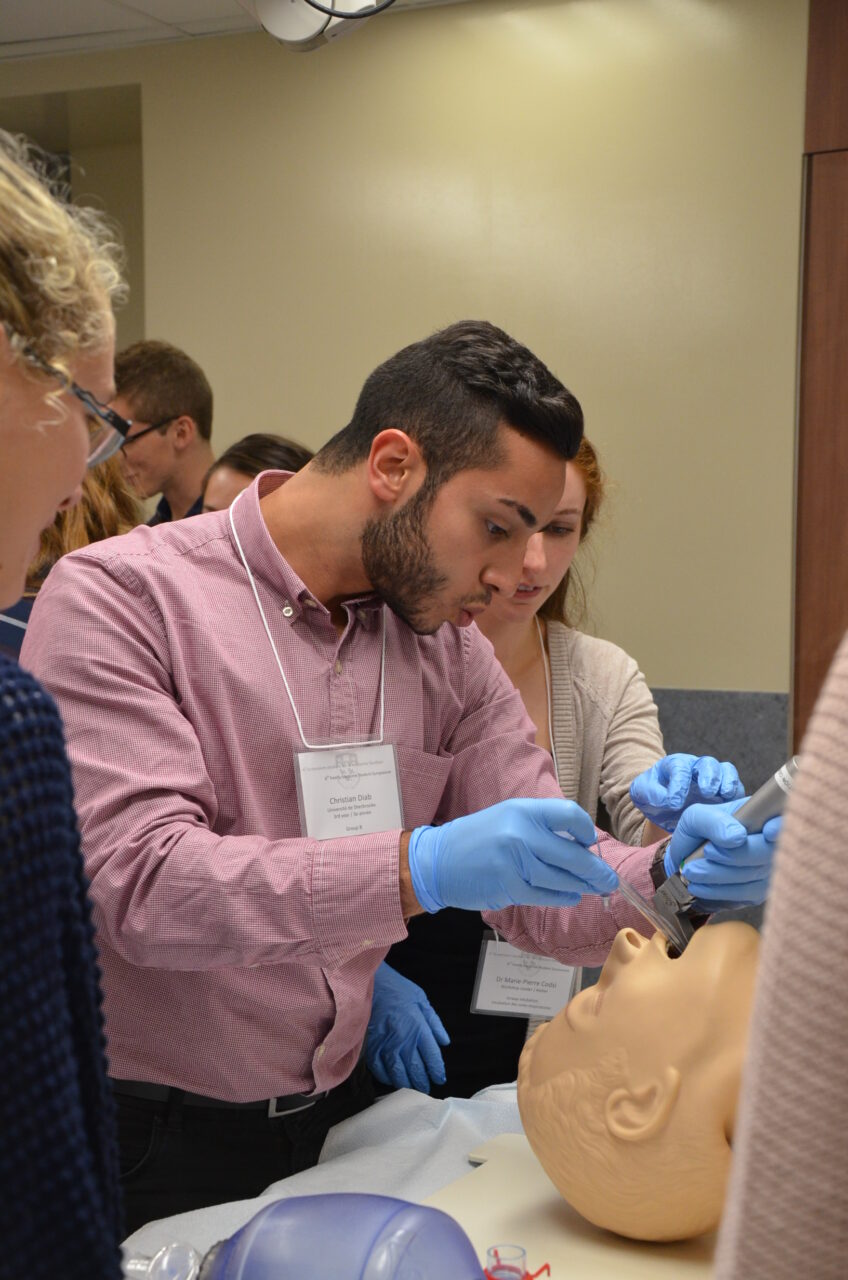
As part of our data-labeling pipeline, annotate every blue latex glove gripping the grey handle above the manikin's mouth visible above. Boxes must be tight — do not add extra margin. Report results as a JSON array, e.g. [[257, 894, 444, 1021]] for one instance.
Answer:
[[662, 796, 783, 906]]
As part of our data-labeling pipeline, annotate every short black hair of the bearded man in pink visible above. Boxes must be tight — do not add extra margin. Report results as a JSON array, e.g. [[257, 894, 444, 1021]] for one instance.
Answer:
[[316, 320, 583, 490]]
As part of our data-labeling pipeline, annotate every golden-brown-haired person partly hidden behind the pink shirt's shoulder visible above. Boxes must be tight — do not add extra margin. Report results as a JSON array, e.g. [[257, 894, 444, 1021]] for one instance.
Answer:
[[0, 457, 141, 658]]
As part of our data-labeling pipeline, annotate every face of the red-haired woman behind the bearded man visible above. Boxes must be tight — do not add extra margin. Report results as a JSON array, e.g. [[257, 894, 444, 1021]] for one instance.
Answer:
[[483, 462, 585, 630]]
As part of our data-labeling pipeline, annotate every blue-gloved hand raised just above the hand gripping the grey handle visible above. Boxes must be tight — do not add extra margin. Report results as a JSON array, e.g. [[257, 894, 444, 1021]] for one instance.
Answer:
[[630, 751, 744, 831]]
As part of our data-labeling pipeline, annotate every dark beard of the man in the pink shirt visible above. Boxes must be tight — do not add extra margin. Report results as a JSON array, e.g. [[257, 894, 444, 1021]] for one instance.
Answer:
[[361, 484, 447, 635]]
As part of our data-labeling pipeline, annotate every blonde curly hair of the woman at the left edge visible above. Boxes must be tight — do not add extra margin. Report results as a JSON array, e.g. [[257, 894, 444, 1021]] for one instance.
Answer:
[[0, 129, 126, 378]]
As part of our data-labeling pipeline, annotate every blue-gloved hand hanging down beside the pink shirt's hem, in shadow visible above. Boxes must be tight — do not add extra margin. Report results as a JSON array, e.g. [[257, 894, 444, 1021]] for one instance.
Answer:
[[365, 961, 451, 1093]]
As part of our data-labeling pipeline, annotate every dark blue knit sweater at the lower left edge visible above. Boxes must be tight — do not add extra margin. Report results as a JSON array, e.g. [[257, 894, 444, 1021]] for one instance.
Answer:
[[0, 655, 122, 1280]]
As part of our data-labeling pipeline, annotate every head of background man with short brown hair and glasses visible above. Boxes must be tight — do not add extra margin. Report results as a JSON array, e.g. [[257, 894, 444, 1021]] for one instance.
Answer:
[[111, 339, 215, 525]]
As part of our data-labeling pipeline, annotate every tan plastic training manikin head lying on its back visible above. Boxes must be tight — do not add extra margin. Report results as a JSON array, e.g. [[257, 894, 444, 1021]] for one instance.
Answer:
[[518, 922, 760, 1240]]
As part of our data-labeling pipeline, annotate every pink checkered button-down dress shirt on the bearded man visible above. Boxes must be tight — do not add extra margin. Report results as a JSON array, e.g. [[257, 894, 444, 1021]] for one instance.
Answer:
[[22, 472, 651, 1102]]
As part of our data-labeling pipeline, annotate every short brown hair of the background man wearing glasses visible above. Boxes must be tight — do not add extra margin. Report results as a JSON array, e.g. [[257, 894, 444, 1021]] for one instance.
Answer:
[[115, 339, 213, 440]]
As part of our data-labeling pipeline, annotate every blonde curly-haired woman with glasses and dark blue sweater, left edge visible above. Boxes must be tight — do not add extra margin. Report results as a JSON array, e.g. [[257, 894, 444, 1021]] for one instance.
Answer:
[[0, 132, 128, 1280]]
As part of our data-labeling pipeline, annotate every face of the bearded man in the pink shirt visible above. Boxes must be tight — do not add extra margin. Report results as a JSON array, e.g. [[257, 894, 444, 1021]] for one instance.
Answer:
[[363, 426, 565, 635]]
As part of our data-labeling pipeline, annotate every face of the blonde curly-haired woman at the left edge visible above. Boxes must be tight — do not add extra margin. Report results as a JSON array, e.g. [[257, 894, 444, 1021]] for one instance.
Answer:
[[0, 334, 114, 607]]
